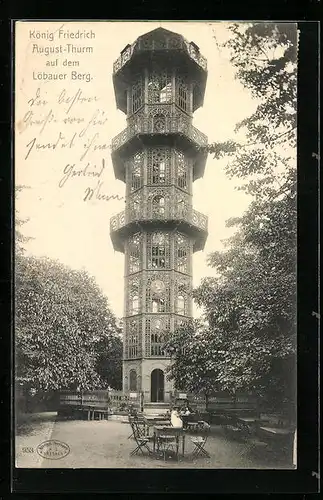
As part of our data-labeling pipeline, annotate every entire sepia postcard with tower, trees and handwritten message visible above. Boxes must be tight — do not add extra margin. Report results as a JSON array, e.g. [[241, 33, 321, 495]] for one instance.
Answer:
[[14, 21, 298, 469]]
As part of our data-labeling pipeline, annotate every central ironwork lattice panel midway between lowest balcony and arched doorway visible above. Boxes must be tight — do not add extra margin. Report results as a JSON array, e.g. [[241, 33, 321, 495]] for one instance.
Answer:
[[146, 273, 170, 313]]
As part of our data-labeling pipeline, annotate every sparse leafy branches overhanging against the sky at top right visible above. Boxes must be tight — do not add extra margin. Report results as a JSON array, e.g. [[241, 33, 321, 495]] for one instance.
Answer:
[[207, 23, 297, 198]]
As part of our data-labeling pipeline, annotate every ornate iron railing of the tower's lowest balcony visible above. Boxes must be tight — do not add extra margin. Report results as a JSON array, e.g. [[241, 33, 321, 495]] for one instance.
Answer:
[[110, 203, 208, 232]]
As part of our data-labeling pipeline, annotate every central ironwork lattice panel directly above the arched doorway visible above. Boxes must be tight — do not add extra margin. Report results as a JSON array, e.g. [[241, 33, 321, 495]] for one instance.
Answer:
[[145, 316, 170, 356]]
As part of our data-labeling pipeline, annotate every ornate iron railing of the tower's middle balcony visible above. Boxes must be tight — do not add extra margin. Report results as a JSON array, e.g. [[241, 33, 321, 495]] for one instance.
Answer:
[[111, 116, 208, 152]]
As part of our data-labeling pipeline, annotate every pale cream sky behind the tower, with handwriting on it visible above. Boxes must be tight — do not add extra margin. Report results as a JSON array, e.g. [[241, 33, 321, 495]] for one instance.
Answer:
[[15, 21, 256, 317]]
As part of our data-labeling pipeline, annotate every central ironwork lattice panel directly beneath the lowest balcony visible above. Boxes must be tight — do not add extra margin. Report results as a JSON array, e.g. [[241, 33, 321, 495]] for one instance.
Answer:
[[147, 232, 170, 269]]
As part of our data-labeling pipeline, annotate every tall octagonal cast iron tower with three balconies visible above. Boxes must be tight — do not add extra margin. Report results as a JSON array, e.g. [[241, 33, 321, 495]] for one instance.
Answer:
[[110, 28, 207, 406]]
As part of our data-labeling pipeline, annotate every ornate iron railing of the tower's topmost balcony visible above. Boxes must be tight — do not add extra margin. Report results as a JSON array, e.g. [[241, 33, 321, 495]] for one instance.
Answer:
[[113, 36, 207, 73]]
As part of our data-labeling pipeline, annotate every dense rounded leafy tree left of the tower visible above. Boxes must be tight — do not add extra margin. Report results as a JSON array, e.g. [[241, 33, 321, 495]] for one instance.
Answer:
[[15, 254, 121, 391]]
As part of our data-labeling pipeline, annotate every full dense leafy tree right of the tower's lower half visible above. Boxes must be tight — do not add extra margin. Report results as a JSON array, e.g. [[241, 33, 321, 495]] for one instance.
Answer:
[[194, 186, 297, 408]]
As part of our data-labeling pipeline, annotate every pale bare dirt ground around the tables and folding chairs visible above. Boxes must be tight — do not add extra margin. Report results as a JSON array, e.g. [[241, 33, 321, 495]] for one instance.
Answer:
[[15, 413, 293, 469]]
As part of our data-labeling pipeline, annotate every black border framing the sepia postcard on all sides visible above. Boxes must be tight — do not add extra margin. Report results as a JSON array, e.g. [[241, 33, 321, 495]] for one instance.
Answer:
[[1, 2, 320, 498]]
